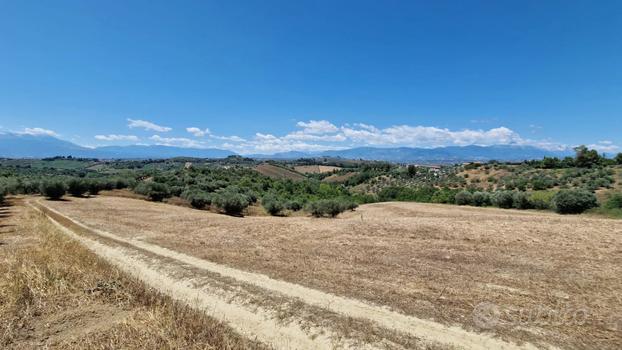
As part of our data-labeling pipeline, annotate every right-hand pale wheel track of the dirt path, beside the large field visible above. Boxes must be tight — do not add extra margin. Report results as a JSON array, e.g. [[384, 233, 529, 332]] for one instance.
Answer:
[[35, 202, 554, 350]]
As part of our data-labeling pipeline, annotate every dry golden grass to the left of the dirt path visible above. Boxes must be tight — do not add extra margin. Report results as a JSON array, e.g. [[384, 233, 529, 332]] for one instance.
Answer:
[[0, 199, 263, 349]]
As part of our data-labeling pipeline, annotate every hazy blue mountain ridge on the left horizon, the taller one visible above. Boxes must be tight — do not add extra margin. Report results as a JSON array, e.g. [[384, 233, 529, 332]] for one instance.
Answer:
[[0, 133, 235, 159]]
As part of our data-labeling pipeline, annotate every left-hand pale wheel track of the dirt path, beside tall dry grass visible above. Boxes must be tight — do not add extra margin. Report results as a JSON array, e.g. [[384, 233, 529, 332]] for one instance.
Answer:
[[29, 203, 380, 350]]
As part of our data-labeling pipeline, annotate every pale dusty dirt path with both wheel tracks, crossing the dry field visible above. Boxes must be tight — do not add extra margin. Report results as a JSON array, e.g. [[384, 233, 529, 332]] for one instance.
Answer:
[[31, 201, 556, 349]]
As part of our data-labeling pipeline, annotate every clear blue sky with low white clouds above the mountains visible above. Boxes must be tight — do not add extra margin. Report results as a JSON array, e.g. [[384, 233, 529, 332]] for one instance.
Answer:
[[0, 0, 622, 153]]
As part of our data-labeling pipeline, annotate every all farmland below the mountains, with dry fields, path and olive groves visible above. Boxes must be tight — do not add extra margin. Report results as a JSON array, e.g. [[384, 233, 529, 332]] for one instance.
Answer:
[[0, 149, 622, 350]]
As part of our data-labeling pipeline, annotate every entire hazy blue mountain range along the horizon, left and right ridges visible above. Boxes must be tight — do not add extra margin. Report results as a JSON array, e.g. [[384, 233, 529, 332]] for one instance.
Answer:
[[0, 133, 572, 163]]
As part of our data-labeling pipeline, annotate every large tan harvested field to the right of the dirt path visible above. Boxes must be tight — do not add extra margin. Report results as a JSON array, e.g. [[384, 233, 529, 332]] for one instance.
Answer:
[[44, 196, 622, 349]]
